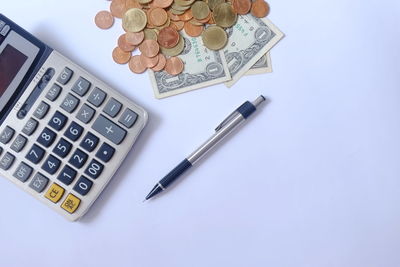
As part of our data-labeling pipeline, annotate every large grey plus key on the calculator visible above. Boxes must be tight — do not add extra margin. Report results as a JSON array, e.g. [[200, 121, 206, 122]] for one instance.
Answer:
[[92, 115, 126, 145]]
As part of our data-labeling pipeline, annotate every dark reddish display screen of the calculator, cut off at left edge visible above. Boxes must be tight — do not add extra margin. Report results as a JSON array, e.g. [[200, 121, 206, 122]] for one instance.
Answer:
[[0, 44, 28, 97]]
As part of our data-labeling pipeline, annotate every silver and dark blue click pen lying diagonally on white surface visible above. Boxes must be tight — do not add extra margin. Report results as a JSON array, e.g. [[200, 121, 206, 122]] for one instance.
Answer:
[[145, 95, 266, 200]]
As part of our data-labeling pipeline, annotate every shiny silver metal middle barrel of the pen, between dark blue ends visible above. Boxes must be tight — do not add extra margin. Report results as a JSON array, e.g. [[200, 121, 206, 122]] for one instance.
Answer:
[[187, 113, 245, 165]]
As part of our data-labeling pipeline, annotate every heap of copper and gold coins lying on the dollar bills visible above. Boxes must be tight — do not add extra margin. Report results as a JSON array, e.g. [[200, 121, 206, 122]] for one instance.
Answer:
[[95, 0, 270, 75]]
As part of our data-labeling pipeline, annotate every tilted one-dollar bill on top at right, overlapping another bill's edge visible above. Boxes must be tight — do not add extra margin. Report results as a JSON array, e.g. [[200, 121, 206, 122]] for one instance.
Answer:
[[224, 14, 284, 87]]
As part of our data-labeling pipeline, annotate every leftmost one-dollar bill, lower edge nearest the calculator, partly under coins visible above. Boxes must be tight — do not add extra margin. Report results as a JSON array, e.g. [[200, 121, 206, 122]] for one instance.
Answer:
[[149, 31, 231, 98]]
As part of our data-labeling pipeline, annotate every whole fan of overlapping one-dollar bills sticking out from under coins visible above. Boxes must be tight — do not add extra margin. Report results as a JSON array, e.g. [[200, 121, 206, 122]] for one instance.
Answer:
[[150, 15, 284, 98]]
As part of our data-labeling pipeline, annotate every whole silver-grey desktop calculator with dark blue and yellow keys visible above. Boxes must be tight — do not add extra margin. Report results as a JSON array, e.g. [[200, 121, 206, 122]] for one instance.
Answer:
[[0, 14, 148, 221]]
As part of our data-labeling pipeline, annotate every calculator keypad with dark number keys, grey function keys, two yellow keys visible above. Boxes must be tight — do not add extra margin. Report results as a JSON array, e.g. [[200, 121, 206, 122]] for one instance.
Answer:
[[0, 55, 147, 221]]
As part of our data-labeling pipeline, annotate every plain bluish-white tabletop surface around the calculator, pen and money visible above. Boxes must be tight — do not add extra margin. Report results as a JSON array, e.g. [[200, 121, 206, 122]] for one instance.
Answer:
[[0, 0, 400, 267]]
